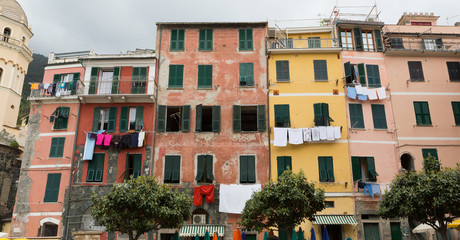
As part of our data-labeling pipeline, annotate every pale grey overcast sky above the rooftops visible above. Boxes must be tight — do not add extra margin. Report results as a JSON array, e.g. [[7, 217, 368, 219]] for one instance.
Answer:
[[17, 0, 460, 56]]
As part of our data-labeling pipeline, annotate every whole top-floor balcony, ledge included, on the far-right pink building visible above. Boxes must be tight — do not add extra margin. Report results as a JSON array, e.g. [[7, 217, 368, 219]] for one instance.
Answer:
[[384, 38, 460, 56]]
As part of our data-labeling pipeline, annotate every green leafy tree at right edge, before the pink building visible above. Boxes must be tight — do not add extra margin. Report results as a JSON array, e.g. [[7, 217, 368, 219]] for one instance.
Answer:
[[377, 155, 460, 240]]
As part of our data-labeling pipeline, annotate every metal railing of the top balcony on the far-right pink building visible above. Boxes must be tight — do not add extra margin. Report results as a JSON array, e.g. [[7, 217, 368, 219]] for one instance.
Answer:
[[385, 38, 460, 52]]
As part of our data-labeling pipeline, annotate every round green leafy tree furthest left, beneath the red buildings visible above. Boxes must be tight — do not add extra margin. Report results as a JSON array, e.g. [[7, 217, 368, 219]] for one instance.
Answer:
[[91, 176, 192, 240]]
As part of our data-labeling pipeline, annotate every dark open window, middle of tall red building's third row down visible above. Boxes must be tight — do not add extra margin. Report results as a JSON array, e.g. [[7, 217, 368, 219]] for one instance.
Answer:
[[195, 104, 220, 132]]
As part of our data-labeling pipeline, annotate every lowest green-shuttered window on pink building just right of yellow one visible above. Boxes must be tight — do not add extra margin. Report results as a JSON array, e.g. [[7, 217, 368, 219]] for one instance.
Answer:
[[351, 157, 378, 182]]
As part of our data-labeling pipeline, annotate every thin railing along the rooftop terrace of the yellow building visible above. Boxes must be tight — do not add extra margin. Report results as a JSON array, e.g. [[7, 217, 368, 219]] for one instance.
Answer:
[[268, 38, 338, 49]]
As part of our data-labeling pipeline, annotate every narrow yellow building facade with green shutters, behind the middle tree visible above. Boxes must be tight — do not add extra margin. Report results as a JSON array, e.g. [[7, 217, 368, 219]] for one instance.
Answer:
[[268, 26, 357, 239]]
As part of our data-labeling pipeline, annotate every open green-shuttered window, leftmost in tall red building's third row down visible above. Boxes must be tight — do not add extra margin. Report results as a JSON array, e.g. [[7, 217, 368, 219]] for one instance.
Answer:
[[157, 105, 190, 132]]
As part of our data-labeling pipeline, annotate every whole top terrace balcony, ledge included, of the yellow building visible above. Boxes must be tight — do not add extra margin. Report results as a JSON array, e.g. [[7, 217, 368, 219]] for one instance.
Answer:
[[267, 38, 342, 54]]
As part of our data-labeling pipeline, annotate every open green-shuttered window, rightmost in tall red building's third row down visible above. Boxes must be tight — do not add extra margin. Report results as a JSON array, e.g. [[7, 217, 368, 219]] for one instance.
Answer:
[[233, 105, 267, 132]]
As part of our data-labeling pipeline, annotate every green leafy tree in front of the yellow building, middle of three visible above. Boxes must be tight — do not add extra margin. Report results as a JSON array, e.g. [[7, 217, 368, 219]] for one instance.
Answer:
[[240, 170, 325, 239]]
